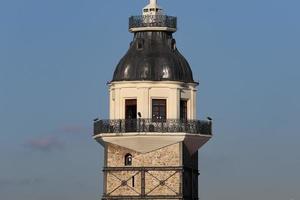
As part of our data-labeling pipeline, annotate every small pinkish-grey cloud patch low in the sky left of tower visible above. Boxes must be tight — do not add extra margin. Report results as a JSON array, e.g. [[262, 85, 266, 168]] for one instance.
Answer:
[[25, 137, 64, 152]]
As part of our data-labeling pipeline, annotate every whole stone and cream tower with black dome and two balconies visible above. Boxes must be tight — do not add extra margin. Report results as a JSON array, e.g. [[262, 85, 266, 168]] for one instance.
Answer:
[[94, 0, 212, 200]]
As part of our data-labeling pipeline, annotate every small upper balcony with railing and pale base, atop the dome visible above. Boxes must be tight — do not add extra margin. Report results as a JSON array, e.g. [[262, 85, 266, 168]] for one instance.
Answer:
[[129, 15, 177, 32]]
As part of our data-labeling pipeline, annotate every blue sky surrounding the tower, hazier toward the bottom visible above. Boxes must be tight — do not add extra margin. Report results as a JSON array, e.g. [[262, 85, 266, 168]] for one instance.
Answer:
[[0, 0, 300, 200]]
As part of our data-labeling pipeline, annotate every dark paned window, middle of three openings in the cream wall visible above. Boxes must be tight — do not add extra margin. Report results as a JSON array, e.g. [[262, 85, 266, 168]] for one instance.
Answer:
[[152, 99, 167, 121]]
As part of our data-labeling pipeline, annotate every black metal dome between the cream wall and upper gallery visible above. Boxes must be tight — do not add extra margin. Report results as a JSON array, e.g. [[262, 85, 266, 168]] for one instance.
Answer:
[[112, 32, 194, 83]]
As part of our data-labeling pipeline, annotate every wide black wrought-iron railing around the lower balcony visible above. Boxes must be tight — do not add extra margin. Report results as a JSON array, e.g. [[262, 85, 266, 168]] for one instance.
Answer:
[[94, 119, 212, 135]]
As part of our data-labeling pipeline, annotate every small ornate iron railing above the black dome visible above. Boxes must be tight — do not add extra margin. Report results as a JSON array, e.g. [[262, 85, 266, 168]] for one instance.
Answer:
[[129, 15, 177, 29]]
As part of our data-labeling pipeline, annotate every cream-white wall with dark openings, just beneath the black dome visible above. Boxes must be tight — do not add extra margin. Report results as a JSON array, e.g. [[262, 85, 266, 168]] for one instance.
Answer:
[[109, 81, 197, 119]]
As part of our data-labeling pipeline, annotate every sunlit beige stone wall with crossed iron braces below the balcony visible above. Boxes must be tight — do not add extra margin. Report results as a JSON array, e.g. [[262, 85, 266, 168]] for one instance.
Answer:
[[106, 143, 182, 196]]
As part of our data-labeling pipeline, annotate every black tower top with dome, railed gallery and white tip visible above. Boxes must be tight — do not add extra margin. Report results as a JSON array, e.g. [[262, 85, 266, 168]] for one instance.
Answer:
[[112, 0, 194, 83]]
